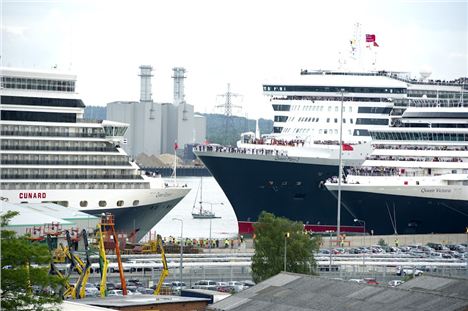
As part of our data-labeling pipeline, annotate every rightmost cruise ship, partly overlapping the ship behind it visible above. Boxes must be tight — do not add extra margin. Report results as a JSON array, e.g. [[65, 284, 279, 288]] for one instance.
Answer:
[[325, 87, 468, 234]]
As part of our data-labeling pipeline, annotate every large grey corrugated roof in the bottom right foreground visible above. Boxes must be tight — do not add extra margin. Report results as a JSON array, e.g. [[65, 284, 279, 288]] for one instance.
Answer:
[[208, 273, 468, 311]]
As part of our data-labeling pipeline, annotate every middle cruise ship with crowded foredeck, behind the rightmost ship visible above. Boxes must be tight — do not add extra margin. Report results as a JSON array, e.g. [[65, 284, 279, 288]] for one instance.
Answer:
[[195, 70, 462, 232]]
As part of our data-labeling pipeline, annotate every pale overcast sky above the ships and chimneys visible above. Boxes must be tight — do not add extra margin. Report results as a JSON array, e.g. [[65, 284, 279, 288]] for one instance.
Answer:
[[0, 0, 468, 119]]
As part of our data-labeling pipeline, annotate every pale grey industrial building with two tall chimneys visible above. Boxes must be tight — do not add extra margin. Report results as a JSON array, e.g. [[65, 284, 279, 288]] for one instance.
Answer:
[[107, 65, 206, 157]]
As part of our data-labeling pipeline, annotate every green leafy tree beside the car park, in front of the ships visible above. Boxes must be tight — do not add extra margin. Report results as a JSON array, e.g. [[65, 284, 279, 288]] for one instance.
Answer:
[[252, 211, 320, 283]]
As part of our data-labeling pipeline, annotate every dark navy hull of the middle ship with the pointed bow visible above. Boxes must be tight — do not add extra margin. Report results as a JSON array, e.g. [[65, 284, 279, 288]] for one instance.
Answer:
[[197, 152, 350, 224]]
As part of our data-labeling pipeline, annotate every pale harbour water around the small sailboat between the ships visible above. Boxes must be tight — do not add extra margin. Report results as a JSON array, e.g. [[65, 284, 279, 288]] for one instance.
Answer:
[[152, 177, 238, 239]]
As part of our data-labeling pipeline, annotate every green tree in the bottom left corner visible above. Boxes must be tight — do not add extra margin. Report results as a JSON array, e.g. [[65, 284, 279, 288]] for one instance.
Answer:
[[1, 211, 62, 310]]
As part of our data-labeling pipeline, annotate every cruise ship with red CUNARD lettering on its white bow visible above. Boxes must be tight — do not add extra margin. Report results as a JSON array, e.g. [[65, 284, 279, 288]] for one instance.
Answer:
[[0, 68, 189, 240]]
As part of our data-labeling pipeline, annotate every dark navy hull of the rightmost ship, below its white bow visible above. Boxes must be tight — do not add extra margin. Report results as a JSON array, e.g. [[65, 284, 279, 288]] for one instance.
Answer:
[[331, 186, 468, 234]]
